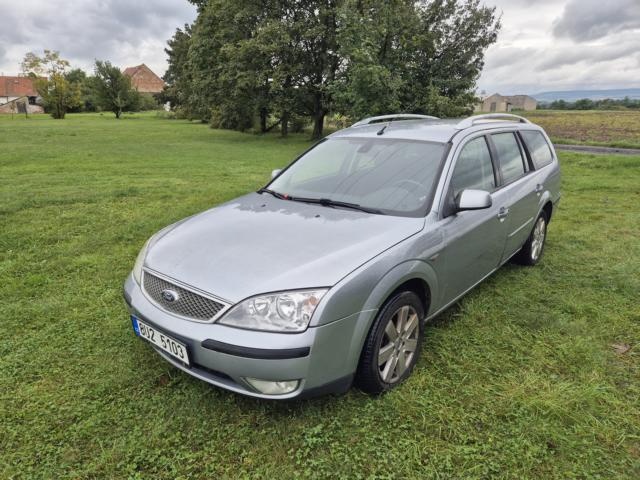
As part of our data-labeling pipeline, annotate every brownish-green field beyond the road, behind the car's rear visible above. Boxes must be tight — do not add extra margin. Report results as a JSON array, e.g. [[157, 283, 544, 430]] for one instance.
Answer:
[[516, 110, 640, 148]]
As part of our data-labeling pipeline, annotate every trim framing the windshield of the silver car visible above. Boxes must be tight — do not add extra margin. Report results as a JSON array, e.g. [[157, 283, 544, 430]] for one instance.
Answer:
[[257, 135, 452, 218]]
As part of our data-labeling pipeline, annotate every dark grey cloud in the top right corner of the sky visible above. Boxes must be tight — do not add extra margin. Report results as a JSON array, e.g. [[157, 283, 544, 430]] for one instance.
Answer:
[[553, 0, 640, 42]]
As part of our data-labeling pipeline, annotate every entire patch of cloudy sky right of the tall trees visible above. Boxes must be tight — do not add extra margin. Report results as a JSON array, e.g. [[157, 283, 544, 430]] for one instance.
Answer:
[[478, 0, 640, 94]]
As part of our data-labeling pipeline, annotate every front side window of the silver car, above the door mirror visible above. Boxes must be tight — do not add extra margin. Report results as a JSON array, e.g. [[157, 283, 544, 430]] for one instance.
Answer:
[[451, 137, 496, 198]]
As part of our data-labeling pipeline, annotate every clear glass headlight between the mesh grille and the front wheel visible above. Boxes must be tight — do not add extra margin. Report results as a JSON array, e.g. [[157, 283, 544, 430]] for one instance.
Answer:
[[218, 288, 327, 332]]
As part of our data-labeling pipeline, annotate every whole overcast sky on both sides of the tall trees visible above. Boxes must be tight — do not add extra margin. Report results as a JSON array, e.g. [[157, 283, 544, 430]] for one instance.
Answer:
[[0, 0, 640, 94]]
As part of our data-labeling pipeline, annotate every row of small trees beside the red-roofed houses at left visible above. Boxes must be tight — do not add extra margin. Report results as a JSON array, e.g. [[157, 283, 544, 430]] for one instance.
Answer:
[[21, 50, 160, 119]]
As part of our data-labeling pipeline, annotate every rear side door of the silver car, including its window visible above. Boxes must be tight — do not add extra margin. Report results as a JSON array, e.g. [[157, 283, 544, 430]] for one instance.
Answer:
[[489, 131, 540, 261]]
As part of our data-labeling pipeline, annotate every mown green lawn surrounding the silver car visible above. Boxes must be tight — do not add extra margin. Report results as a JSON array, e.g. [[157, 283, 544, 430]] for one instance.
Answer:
[[0, 115, 640, 479]]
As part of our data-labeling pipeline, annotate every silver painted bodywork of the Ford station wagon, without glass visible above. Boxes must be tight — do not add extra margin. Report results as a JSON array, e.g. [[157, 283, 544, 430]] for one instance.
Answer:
[[125, 115, 560, 398]]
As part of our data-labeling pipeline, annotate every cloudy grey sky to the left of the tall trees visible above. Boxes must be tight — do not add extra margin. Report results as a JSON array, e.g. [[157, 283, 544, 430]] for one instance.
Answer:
[[0, 0, 196, 75]]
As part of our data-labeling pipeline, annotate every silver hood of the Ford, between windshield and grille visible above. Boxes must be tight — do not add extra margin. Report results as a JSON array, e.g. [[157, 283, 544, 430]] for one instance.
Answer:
[[145, 193, 424, 303]]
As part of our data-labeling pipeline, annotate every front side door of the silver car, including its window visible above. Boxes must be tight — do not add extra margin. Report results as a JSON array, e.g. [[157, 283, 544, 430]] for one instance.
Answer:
[[439, 135, 508, 305]]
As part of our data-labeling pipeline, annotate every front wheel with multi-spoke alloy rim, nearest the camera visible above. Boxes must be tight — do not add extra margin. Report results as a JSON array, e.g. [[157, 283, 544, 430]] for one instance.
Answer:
[[356, 292, 424, 394]]
